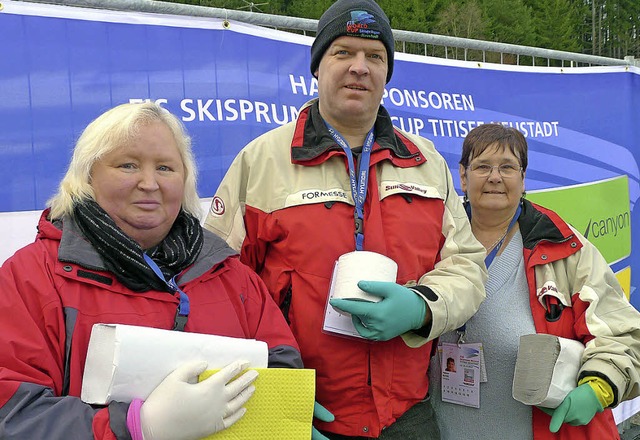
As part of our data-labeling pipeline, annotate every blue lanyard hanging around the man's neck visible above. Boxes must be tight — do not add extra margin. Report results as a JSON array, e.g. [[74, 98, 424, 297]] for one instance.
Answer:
[[325, 121, 374, 251]]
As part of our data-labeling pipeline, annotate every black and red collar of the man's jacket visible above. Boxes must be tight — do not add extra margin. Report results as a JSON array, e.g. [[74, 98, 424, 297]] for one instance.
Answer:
[[291, 99, 426, 168]]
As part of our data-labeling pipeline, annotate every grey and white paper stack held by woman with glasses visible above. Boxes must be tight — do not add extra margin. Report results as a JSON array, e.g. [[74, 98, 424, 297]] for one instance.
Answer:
[[513, 333, 584, 408]]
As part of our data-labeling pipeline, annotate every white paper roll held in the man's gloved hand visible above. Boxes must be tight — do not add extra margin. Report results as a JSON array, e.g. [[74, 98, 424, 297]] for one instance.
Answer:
[[331, 251, 398, 304]]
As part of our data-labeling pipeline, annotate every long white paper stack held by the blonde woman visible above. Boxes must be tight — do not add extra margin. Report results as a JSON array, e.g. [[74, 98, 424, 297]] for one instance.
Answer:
[[80, 324, 268, 405]]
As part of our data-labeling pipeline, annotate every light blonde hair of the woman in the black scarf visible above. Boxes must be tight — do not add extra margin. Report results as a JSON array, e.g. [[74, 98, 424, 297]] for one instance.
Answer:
[[47, 102, 200, 219]]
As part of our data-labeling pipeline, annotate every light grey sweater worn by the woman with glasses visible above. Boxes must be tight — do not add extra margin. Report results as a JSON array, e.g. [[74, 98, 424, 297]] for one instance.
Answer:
[[429, 231, 535, 440]]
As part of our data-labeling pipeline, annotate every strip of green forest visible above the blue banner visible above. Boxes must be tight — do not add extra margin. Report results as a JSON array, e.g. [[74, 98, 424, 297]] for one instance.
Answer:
[[161, 0, 640, 62]]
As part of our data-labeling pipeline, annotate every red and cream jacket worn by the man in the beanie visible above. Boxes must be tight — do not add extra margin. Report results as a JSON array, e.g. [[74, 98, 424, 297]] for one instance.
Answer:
[[205, 101, 486, 437]]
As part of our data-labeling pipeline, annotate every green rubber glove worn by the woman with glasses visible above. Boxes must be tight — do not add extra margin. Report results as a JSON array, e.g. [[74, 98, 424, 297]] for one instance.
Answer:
[[540, 383, 604, 432]]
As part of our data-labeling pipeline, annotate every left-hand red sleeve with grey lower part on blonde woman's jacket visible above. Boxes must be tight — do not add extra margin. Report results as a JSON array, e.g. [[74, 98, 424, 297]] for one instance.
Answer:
[[0, 241, 122, 440]]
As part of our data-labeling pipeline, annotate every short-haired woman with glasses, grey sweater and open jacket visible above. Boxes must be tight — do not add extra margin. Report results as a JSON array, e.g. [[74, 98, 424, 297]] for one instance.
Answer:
[[430, 124, 640, 440]]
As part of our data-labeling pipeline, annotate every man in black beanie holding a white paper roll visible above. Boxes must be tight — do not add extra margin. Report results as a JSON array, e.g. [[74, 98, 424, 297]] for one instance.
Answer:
[[205, 0, 486, 440]]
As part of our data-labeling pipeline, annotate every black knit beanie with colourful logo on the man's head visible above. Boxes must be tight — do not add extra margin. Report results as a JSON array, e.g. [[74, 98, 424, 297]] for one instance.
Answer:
[[311, 0, 395, 82]]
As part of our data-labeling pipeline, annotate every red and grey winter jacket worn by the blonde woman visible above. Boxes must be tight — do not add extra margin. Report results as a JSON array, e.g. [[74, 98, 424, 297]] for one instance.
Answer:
[[0, 211, 301, 440]]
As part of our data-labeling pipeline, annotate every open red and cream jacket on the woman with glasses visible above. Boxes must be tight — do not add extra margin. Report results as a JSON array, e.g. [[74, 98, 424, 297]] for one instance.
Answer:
[[518, 200, 640, 440]]
